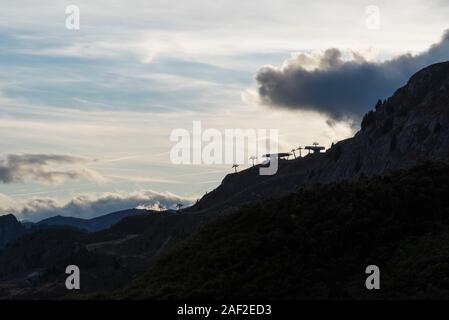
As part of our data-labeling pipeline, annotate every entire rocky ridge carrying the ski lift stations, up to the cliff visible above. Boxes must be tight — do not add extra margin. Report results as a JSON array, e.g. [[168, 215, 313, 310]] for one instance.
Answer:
[[192, 62, 449, 210]]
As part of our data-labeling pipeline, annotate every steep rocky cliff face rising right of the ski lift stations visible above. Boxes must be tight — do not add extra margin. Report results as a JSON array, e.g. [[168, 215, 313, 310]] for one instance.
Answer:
[[336, 63, 449, 175]]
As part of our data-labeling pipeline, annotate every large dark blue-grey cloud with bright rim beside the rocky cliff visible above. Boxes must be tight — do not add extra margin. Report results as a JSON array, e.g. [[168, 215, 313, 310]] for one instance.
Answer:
[[256, 31, 449, 120]]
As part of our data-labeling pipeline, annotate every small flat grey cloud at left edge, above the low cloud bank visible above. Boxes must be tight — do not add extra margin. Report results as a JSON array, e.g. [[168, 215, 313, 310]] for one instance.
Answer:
[[0, 154, 100, 183]]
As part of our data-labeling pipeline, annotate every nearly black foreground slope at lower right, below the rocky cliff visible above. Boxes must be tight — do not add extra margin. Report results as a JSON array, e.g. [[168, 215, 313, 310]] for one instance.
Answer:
[[103, 164, 449, 299]]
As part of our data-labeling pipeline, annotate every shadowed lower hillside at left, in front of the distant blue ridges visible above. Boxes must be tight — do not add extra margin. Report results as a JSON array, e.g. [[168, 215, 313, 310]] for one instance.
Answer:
[[0, 212, 207, 299]]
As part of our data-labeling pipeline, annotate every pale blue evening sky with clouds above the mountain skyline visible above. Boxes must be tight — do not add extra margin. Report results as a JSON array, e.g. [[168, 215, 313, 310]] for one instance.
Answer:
[[0, 0, 449, 221]]
